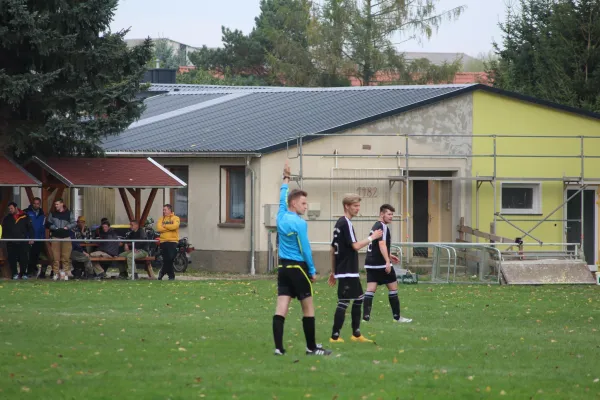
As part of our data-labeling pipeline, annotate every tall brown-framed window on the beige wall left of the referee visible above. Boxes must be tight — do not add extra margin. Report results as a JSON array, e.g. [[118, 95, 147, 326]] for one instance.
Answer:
[[221, 166, 246, 224]]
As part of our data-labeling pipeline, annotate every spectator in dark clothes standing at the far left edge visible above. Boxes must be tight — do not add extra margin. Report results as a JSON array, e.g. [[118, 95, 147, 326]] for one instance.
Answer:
[[2, 202, 34, 280]]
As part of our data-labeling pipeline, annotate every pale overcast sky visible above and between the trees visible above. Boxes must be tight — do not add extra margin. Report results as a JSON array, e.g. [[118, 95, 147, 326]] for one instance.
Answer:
[[111, 0, 507, 56]]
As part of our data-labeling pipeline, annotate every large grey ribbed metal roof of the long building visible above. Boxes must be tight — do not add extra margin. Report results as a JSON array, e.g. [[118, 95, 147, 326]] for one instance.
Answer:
[[103, 84, 477, 153]]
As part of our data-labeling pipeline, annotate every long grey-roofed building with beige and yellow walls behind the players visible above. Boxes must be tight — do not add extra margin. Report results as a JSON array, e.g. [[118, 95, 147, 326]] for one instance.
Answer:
[[89, 84, 600, 273]]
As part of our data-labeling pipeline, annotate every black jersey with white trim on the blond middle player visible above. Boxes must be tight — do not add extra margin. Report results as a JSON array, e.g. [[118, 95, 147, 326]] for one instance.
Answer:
[[331, 216, 359, 278]]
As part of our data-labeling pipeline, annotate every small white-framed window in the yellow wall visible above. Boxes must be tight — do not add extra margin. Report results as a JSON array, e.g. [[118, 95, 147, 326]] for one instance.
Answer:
[[501, 183, 542, 214]]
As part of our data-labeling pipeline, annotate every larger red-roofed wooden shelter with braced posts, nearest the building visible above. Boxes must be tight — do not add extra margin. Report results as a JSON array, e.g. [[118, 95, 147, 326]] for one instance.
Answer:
[[25, 157, 187, 226]]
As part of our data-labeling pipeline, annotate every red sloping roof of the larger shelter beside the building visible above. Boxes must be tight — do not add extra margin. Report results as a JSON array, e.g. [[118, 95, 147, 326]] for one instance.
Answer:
[[28, 157, 186, 188]]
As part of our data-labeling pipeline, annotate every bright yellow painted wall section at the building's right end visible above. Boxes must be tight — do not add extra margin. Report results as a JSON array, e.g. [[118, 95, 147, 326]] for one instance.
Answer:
[[472, 91, 600, 256]]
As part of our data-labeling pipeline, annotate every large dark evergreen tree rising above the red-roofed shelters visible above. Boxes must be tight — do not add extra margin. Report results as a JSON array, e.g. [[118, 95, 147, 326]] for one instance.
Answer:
[[0, 0, 152, 157]]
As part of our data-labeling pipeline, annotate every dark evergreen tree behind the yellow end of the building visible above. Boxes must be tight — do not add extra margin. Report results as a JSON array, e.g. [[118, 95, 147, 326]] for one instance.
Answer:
[[488, 0, 600, 112]]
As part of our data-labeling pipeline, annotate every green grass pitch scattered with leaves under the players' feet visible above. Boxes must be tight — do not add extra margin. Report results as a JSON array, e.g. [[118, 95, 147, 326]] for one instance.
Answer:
[[0, 278, 600, 400]]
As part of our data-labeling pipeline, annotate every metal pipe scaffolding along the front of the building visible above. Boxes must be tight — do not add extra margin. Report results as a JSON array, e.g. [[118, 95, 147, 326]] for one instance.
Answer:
[[286, 133, 600, 263]]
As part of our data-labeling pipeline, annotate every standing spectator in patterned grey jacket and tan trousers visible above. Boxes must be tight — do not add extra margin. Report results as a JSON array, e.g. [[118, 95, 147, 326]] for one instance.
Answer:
[[46, 199, 77, 281]]
